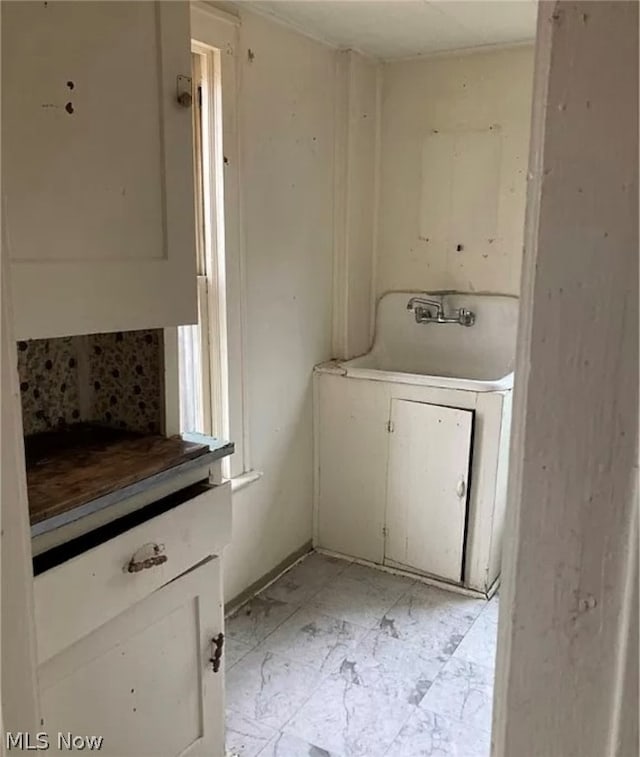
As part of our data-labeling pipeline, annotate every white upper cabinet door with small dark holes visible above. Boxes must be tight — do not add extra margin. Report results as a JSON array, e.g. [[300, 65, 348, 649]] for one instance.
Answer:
[[2, 1, 196, 339]]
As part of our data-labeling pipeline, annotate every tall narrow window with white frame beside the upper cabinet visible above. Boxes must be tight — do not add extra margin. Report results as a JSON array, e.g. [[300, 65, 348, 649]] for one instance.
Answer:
[[178, 3, 252, 487]]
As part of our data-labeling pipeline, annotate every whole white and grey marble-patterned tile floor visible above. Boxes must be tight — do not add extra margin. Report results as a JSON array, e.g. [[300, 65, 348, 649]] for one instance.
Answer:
[[225, 552, 498, 757]]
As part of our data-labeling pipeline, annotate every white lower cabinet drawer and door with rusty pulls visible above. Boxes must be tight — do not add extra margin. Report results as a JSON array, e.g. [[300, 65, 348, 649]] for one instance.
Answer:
[[34, 483, 231, 757]]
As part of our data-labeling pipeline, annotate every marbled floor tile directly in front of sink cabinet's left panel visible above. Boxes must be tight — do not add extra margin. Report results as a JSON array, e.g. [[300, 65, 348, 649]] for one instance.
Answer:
[[311, 563, 415, 628]]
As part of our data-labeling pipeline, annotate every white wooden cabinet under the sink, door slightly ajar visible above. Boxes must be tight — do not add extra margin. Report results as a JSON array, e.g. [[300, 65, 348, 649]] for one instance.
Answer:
[[314, 368, 511, 592]]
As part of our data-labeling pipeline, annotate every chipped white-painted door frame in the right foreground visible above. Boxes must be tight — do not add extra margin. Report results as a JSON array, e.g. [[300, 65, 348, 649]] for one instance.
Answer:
[[493, 2, 638, 757]]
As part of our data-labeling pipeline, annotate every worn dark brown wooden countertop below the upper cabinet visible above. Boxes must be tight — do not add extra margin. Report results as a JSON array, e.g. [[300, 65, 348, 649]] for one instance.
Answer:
[[25, 424, 209, 525]]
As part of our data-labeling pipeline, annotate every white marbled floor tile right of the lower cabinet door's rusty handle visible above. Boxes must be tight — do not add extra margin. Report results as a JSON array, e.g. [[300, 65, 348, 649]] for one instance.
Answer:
[[226, 650, 320, 730]]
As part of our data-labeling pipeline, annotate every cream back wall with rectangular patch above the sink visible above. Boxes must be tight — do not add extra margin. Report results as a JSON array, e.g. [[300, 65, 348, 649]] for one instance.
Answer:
[[376, 46, 533, 296]]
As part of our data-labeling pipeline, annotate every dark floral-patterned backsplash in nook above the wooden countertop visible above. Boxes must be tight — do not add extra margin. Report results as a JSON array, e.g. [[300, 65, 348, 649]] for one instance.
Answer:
[[18, 329, 163, 436]]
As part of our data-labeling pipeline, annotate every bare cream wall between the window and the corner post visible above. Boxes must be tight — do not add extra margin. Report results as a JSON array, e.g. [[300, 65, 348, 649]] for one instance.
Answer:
[[212, 12, 335, 601]]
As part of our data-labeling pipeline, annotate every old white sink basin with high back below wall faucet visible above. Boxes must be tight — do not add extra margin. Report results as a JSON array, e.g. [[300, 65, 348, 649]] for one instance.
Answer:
[[322, 292, 518, 391]]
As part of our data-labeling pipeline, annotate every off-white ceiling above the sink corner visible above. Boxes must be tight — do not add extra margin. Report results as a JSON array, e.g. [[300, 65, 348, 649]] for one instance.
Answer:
[[242, 0, 537, 60]]
